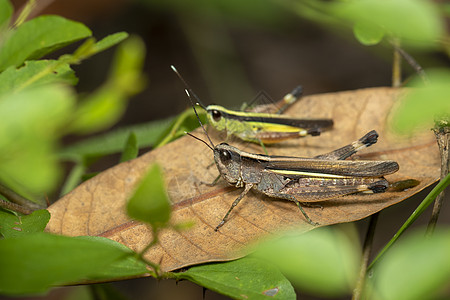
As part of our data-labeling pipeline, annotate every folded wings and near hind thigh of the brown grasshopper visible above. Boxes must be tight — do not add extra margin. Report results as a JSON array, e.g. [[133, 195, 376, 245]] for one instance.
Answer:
[[265, 157, 398, 202]]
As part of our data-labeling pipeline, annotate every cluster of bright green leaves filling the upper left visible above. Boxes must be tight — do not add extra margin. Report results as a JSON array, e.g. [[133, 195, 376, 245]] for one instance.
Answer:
[[0, 1, 144, 201]]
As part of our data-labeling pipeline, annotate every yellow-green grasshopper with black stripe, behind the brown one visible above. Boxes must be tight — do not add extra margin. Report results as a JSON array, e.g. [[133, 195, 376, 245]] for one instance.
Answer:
[[171, 66, 333, 144]]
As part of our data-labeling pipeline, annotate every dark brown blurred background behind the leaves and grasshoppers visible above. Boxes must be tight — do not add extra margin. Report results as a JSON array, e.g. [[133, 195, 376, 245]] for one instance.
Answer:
[[7, 0, 450, 299]]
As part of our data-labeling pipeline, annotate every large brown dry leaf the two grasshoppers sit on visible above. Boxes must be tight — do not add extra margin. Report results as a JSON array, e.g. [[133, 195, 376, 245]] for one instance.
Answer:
[[47, 88, 440, 271]]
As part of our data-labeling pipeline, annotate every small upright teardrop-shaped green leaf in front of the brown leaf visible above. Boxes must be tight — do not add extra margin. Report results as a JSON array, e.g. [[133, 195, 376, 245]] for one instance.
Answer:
[[127, 164, 171, 228]]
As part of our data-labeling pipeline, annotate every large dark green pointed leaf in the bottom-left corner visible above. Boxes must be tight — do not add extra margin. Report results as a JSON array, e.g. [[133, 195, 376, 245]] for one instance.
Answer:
[[0, 233, 134, 295]]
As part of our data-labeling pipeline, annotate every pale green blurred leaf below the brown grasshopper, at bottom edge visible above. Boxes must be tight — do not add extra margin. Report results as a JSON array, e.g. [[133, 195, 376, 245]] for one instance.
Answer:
[[256, 228, 360, 296]]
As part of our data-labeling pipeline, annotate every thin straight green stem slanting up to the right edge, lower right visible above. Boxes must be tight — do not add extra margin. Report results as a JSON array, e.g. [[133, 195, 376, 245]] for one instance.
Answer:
[[367, 174, 450, 270]]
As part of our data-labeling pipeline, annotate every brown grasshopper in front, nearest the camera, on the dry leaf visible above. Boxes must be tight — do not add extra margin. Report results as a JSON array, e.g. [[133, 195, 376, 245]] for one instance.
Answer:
[[185, 90, 399, 231]]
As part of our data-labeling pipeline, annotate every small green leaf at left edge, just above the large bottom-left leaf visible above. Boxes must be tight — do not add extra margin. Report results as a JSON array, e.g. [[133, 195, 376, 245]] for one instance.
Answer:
[[0, 209, 50, 238]]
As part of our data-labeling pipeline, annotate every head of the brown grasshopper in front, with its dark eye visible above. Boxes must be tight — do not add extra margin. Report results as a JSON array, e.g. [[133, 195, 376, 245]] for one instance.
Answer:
[[214, 143, 241, 184]]
